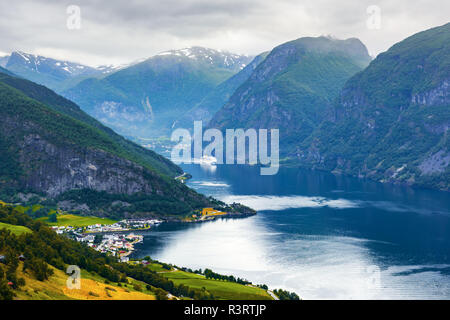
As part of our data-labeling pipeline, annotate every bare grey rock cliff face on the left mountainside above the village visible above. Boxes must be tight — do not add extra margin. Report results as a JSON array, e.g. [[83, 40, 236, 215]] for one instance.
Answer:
[[19, 134, 163, 197]]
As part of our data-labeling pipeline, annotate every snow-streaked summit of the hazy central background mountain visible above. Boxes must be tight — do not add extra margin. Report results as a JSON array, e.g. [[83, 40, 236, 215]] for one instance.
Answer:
[[155, 47, 253, 71]]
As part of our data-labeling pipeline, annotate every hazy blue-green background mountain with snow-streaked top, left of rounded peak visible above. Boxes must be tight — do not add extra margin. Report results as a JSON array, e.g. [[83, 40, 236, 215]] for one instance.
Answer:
[[63, 47, 251, 137]]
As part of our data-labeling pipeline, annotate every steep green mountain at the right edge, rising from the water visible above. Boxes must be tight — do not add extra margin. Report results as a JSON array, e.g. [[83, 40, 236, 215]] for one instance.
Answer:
[[297, 23, 450, 190]]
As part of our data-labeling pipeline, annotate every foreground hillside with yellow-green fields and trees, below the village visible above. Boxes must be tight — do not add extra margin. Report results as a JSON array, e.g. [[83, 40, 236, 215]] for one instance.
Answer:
[[0, 204, 294, 300]]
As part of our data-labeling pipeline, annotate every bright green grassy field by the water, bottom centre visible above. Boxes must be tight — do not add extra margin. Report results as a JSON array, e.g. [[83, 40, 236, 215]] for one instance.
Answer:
[[156, 271, 272, 300]]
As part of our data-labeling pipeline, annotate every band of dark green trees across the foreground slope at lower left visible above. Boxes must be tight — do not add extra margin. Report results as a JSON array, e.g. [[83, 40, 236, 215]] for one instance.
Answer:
[[0, 206, 225, 299]]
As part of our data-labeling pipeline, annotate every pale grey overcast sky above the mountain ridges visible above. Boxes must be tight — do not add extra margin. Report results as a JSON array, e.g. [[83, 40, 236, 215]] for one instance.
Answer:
[[0, 0, 450, 65]]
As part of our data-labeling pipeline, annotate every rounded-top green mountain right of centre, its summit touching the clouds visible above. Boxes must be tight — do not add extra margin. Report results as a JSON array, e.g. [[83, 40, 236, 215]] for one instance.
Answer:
[[209, 37, 370, 155]]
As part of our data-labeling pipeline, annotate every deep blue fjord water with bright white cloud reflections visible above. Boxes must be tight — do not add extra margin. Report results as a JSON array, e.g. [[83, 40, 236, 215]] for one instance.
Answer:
[[137, 165, 450, 299]]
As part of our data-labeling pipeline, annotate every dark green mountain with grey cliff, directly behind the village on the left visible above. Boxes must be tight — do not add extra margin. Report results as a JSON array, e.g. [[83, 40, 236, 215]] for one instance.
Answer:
[[0, 70, 216, 217]]
